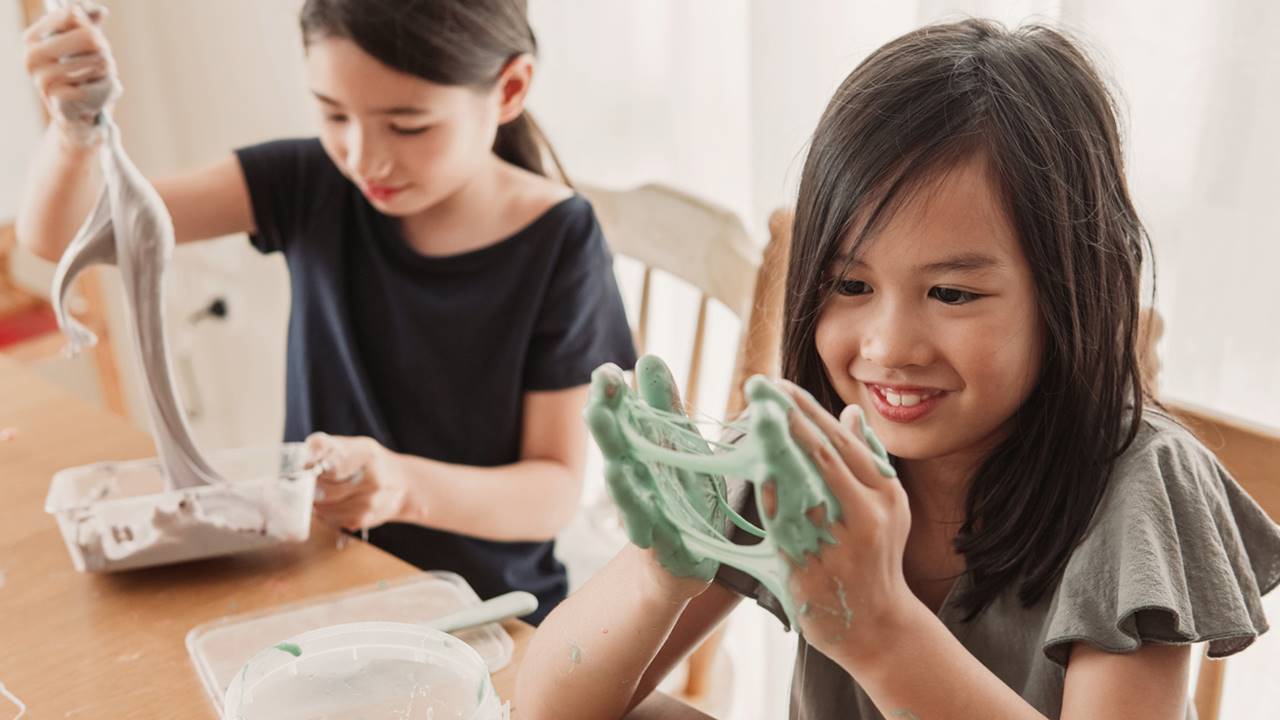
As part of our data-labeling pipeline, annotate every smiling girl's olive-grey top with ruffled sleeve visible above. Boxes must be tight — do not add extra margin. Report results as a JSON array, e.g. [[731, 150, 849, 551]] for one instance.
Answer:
[[717, 411, 1280, 720]]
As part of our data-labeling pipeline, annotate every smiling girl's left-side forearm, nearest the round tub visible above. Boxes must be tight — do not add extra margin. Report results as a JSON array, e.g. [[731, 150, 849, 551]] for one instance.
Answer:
[[516, 546, 689, 720]]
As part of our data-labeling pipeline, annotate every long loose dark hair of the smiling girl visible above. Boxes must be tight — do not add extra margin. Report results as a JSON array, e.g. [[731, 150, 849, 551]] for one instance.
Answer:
[[782, 19, 1149, 619]]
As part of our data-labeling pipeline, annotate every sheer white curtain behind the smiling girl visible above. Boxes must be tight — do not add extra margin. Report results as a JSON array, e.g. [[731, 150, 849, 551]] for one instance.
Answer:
[[531, 0, 1280, 720]]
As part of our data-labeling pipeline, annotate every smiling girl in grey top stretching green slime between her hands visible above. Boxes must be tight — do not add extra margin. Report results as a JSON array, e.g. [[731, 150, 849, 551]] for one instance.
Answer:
[[516, 19, 1280, 720]]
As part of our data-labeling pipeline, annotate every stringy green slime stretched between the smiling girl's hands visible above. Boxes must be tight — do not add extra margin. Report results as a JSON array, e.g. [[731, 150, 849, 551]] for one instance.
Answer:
[[586, 356, 888, 628]]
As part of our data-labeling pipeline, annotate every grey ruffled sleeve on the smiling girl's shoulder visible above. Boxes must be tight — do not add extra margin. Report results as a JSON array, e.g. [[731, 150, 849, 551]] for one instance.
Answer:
[[1044, 409, 1280, 665]]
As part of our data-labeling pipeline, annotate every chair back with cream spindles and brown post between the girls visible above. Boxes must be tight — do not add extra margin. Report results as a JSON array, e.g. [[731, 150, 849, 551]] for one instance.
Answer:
[[579, 184, 790, 415]]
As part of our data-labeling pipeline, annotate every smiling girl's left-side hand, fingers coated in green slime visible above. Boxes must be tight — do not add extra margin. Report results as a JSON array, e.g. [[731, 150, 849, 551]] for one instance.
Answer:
[[586, 356, 724, 600]]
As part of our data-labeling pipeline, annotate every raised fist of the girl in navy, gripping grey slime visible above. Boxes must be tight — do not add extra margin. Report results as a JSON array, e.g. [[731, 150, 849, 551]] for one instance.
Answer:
[[23, 0, 120, 146]]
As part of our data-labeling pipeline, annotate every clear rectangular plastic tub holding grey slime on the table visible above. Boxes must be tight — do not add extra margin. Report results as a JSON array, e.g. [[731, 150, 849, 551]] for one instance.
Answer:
[[45, 443, 317, 573]]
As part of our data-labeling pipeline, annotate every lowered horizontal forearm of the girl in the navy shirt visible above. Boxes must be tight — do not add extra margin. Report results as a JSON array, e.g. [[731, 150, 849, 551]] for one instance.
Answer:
[[392, 454, 582, 542]]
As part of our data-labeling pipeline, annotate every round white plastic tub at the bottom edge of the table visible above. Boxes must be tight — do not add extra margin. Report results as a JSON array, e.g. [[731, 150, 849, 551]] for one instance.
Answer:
[[223, 623, 509, 720]]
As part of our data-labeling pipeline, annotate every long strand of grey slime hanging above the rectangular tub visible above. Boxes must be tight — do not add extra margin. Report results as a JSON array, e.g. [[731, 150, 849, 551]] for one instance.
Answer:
[[46, 0, 221, 489]]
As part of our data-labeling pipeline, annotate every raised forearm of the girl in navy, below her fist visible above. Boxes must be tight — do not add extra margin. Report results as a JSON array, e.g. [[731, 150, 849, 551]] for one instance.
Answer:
[[17, 126, 102, 261]]
